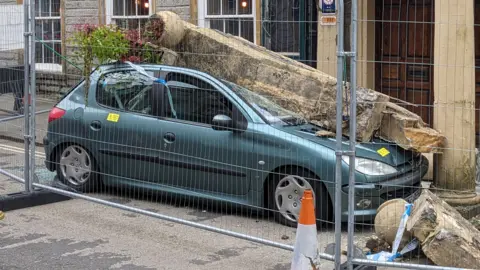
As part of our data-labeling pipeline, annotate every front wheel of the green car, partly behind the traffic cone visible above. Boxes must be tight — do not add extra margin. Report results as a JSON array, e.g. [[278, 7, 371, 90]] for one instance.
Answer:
[[266, 169, 331, 228]]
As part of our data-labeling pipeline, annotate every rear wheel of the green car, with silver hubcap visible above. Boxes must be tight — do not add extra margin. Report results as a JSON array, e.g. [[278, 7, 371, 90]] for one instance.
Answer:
[[56, 145, 97, 192]]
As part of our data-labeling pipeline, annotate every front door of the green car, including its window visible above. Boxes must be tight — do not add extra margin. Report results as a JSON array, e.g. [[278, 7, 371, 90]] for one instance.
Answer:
[[157, 71, 253, 195]]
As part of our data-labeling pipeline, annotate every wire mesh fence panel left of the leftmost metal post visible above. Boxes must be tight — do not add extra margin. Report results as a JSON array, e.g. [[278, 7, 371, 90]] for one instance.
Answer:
[[0, 1, 26, 192]]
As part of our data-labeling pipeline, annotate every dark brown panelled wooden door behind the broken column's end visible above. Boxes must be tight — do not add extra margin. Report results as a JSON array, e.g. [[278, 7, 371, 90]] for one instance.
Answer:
[[375, 0, 434, 125]]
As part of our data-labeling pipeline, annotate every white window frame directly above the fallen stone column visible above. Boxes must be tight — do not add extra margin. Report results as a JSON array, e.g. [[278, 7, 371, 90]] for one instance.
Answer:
[[197, 0, 255, 44]]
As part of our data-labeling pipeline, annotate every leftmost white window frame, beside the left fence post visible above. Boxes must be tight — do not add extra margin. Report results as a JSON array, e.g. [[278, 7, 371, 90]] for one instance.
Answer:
[[35, 0, 63, 72]]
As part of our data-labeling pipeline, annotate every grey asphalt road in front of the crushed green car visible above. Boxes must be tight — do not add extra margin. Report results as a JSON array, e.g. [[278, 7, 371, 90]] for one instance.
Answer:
[[0, 140, 432, 270]]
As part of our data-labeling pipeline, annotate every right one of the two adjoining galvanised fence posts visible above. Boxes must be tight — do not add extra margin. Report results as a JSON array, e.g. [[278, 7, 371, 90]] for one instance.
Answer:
[[347, 0, 358, 270]]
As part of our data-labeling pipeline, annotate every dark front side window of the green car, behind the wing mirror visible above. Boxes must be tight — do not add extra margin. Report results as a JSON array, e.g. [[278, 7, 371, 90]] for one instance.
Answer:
[[166, 73, 232, 125]]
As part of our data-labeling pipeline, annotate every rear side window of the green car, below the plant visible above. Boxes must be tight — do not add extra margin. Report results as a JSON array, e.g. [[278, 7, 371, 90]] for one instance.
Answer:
[[96, 70, 153, 115]]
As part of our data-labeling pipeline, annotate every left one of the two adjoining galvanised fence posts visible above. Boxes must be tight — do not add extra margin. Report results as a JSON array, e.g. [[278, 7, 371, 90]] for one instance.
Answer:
[[335, 0, 345, 269]]
